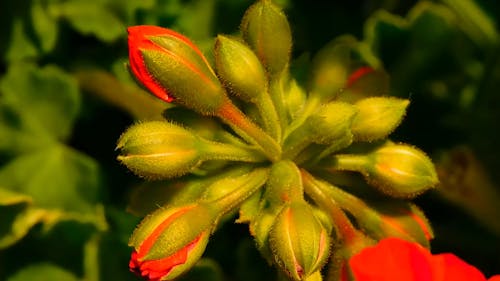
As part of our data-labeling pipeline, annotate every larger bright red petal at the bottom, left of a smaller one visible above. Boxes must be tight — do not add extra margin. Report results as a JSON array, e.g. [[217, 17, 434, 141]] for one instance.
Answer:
[[349, 238, 432, 281]]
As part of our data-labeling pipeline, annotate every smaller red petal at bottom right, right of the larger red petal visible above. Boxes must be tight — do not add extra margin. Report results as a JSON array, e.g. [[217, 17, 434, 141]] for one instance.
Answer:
[[432, 254, 486, 281]]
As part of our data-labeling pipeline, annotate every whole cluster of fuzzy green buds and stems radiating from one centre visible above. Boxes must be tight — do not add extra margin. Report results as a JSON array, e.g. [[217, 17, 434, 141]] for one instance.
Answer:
[[117, 0, 437, 280]]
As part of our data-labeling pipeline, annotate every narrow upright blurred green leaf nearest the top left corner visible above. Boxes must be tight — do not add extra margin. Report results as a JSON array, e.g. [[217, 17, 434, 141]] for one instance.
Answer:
[[31, 0, 59, 53]]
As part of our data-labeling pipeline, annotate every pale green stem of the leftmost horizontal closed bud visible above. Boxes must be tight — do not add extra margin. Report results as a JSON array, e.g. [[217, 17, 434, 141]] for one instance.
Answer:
[[203, 140, 266, 163]]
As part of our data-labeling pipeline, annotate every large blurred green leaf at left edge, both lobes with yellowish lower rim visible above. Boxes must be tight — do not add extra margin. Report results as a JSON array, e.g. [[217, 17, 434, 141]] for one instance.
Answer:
[[0, 63, 106, 247]]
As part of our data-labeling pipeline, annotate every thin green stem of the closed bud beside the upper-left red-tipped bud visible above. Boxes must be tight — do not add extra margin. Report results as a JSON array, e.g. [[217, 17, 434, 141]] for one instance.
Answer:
[[255, 92, 281, 141]]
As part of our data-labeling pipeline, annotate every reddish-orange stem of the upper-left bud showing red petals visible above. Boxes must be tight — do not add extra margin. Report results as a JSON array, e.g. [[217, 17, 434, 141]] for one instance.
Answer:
[[217, 99, 281, 162]]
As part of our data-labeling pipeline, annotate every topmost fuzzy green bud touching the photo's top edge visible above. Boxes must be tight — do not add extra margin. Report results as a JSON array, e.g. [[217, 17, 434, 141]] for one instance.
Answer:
[[241, 0, 292, 76]]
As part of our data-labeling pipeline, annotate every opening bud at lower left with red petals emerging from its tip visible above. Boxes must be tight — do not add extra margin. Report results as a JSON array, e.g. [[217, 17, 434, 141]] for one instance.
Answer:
[[129, 204, 217, 280]]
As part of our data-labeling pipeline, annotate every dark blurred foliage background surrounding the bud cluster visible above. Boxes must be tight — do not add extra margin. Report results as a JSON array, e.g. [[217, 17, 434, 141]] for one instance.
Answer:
[[0, 0, 500, 281]]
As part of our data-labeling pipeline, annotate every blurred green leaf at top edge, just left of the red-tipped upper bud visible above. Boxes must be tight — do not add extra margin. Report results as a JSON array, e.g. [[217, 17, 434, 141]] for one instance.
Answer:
[[54, 0, 125, 43]]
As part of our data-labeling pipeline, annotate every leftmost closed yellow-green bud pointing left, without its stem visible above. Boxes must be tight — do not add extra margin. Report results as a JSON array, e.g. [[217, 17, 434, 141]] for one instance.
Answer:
[[117, 121, 202, 178]]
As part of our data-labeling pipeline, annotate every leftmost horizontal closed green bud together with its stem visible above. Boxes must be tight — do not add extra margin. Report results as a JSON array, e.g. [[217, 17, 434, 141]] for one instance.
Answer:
[[117, 121, 264, 179]]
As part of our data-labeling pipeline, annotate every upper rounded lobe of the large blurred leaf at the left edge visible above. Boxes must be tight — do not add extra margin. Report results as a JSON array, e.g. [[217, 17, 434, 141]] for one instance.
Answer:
[[0, 63, 80, 139]]
